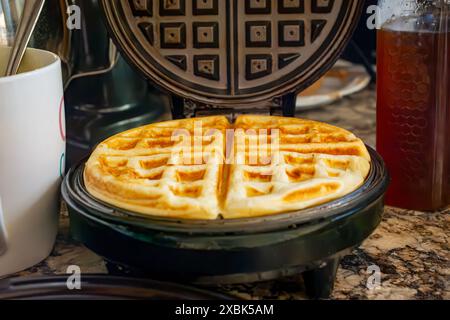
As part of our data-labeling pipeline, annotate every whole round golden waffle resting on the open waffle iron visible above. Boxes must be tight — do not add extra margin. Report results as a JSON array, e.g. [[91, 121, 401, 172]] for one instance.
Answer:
[[84, 116, 370, 220]]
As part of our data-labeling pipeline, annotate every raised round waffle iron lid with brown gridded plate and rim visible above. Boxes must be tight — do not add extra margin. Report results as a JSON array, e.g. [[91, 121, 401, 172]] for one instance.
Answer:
[[101, 0, 363, 109]]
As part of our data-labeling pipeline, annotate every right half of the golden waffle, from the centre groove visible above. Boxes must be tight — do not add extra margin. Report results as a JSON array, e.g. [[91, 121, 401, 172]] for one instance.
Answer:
[[223, 116, 370, 218]]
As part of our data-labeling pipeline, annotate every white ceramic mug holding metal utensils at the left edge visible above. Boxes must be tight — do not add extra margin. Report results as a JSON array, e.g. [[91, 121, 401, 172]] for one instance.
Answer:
[[0, 47, 65, 277]]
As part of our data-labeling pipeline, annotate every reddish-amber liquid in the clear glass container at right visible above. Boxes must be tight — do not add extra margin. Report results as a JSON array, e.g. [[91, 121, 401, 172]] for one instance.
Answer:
[[377, 18, 450, 211]]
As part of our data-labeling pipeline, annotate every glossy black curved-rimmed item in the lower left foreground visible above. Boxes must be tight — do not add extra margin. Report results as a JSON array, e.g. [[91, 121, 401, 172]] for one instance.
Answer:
[[0, 275, 232, 300]]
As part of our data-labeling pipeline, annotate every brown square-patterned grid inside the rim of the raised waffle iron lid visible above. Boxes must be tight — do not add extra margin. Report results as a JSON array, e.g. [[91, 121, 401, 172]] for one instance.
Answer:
[[125, 0, 346, 95]]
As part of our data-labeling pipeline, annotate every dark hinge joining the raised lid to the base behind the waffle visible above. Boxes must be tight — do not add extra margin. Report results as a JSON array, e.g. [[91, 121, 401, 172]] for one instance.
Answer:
[[171, 92, 297, 121]]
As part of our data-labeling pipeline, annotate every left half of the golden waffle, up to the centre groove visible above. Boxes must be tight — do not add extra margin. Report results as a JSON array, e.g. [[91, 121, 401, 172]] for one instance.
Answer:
[[84, 117, 229, 219]]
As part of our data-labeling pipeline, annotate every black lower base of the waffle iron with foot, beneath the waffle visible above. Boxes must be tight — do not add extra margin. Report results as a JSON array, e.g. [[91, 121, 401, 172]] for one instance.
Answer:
[[62, 150, 389, 298]]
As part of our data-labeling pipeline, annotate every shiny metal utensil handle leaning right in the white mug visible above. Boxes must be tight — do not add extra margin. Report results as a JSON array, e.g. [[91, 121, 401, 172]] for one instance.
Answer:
[[6, 0, 45, 77]]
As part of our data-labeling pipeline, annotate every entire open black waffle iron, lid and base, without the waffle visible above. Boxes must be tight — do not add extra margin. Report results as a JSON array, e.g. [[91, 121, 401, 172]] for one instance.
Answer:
[[62, 0, 389, 298]]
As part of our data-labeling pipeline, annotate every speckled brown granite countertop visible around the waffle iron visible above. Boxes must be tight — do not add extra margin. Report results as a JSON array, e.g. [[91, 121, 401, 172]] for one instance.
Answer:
[[10, 88, 450, 299]]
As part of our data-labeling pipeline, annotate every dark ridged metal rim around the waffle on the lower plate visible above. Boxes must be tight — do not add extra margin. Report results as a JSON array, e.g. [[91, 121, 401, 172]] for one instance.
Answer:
[[62, 147, 389, 234]]
